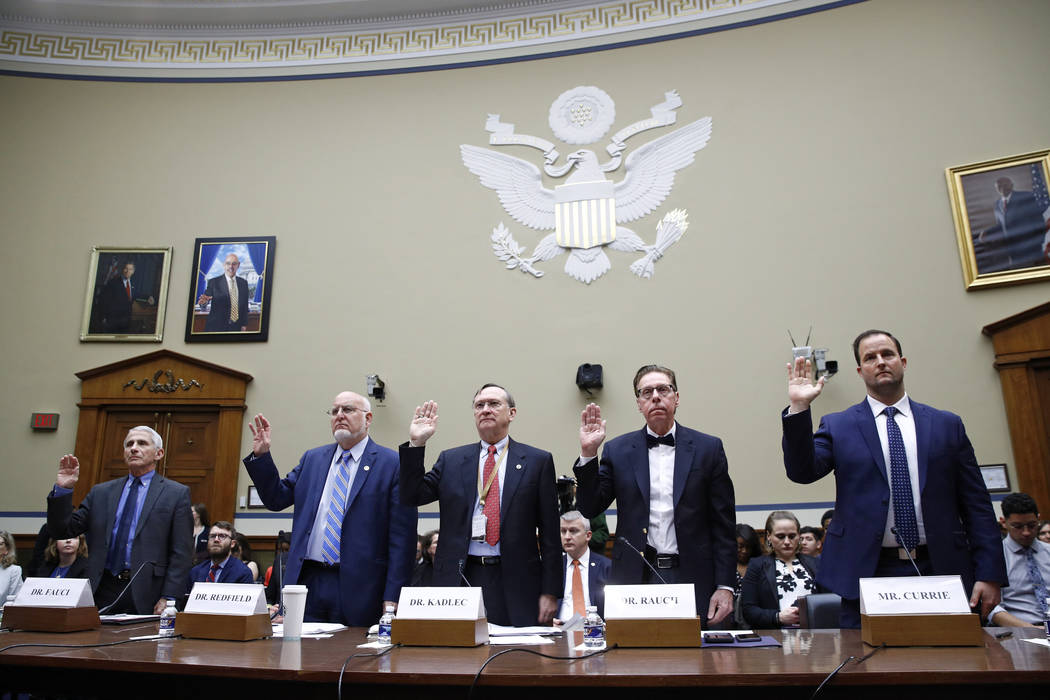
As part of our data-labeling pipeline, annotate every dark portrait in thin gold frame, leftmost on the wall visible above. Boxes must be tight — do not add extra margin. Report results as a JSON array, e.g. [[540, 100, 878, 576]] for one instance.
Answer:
[[80, 246, 171, 342]]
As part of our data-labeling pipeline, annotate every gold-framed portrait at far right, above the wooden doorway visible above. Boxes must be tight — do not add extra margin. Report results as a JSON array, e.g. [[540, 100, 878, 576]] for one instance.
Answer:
[[945, 150, 1050, 291]]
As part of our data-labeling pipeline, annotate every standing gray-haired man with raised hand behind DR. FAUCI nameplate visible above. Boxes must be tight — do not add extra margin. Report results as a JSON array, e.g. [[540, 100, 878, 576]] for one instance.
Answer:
[[47, 425, 193, 615]]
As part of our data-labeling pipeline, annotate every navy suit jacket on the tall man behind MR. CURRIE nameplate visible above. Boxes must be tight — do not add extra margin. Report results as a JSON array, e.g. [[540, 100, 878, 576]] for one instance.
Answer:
[[782, 400, 1008, 598]]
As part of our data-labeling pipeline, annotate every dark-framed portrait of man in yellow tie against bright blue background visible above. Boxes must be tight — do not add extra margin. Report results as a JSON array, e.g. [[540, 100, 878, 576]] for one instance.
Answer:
[[186, 236, 277, 343]]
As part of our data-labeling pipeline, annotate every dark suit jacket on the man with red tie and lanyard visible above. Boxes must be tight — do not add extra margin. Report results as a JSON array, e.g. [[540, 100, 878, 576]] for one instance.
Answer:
[[400, 440, 562, 627]]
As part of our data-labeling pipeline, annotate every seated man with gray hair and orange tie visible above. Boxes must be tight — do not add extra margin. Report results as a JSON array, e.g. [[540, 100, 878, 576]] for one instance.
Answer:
[[557, 510, 612, 622]]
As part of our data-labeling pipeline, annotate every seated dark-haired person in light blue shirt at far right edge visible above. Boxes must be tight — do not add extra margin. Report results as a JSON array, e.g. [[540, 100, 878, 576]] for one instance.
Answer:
[[988, 493, 1050, 628]]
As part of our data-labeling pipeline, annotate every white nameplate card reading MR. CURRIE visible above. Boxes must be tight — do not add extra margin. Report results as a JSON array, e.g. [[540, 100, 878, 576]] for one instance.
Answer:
[[860, 576, 970, 615]]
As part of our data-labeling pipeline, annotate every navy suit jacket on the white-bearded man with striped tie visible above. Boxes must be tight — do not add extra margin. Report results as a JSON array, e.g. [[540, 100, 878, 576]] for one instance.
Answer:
[[245, 438, 417, 627]]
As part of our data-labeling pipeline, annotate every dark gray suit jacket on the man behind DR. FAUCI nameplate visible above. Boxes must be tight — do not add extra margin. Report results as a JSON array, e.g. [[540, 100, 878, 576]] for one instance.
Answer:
[[47, 474, 193, 615]]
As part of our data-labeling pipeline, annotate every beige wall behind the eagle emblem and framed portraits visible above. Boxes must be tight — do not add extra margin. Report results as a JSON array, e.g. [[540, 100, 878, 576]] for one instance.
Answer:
[[0, 0, 1050, 529]]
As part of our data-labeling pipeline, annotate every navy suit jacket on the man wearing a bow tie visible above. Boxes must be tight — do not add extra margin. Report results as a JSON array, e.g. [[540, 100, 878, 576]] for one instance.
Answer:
[[573, 425, 736, 618]]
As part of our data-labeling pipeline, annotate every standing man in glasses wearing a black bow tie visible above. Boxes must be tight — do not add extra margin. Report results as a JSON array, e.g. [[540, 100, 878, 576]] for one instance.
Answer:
[[573, 365, 736, 625]]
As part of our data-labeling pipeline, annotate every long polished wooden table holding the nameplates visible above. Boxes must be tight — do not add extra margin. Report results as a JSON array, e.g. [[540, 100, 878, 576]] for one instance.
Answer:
[[0, 623, 1050, 700]]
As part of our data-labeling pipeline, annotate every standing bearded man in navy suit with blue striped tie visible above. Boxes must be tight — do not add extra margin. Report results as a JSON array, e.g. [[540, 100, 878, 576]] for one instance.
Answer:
[[244, 391, 417, 627]]
